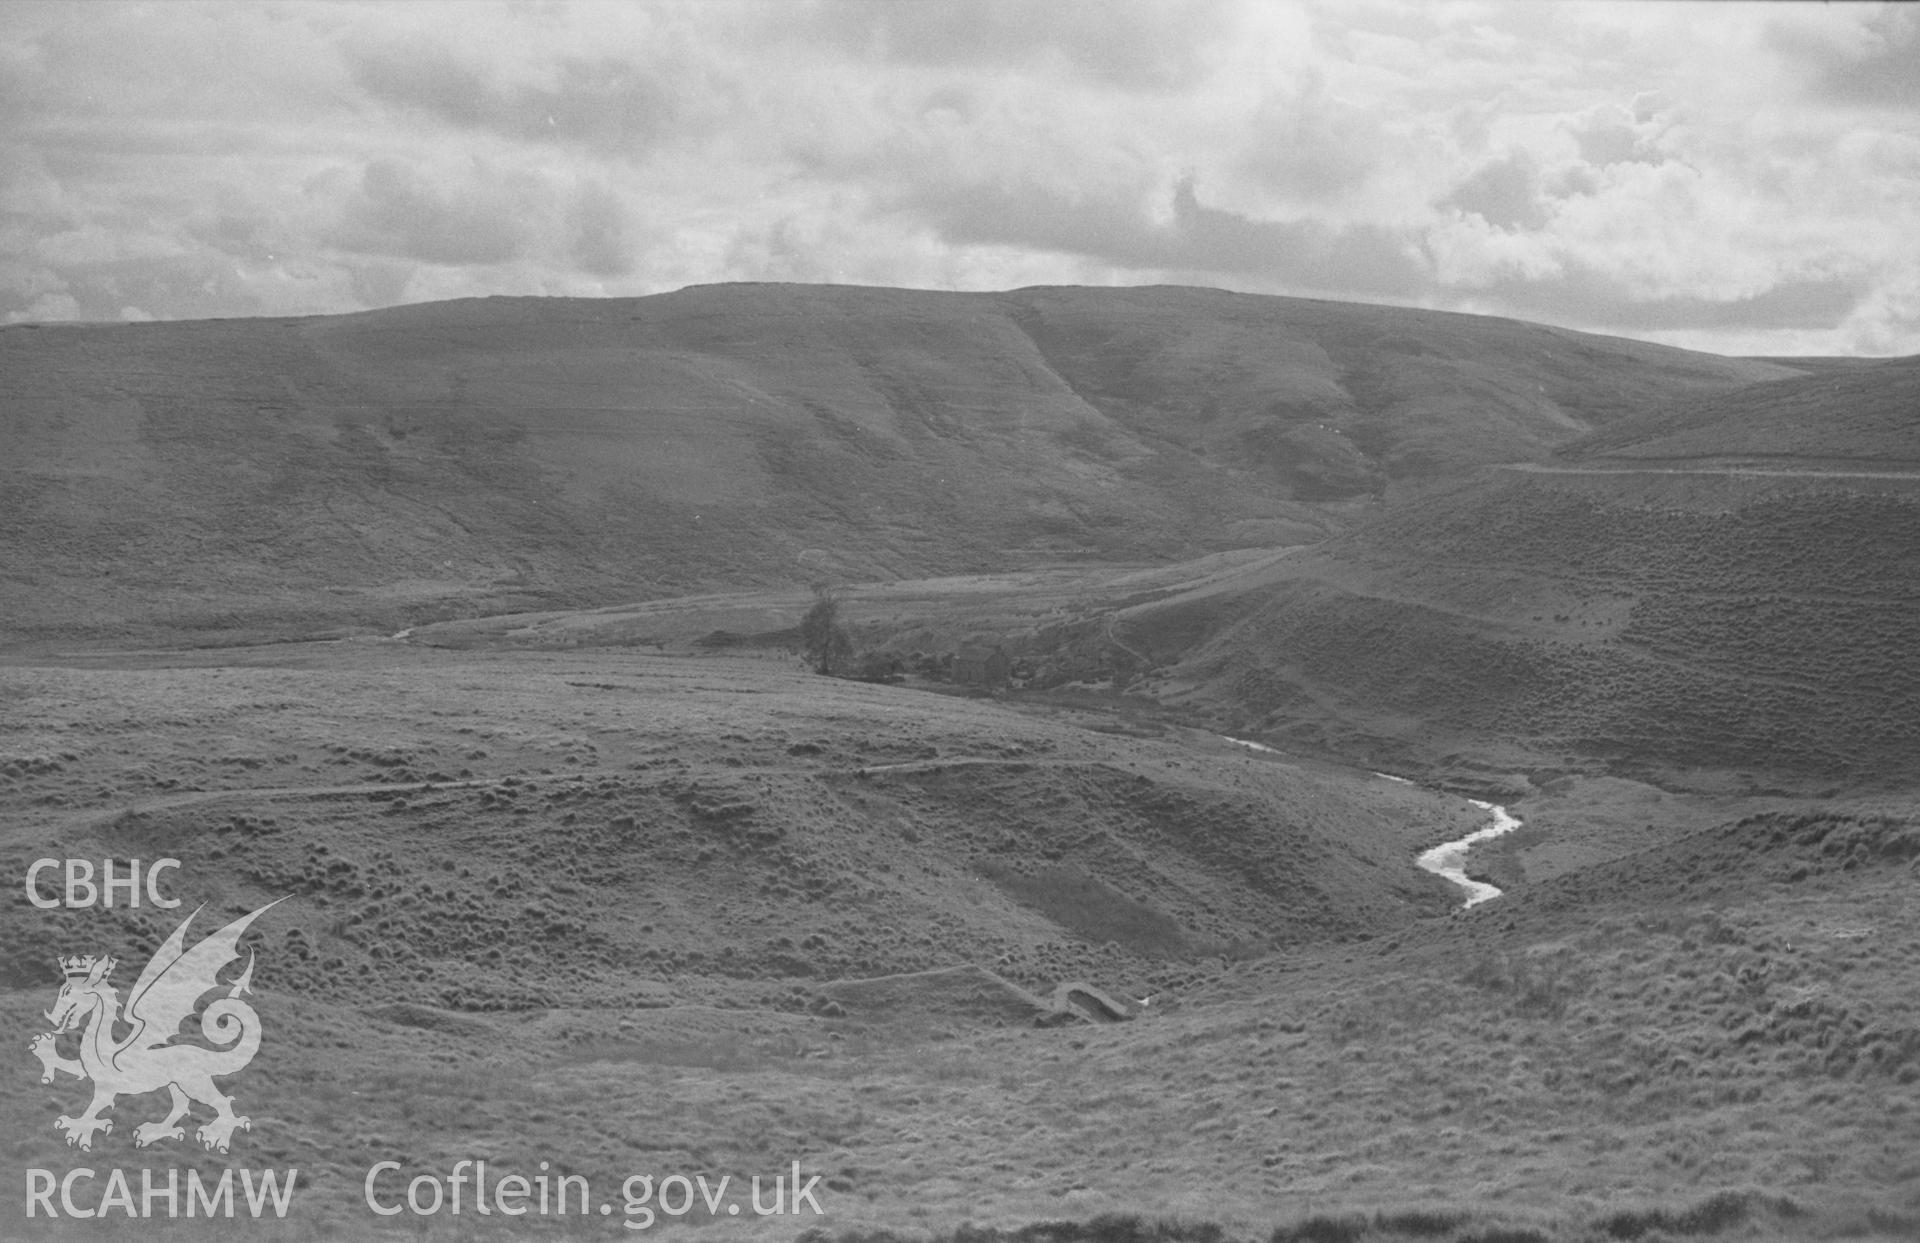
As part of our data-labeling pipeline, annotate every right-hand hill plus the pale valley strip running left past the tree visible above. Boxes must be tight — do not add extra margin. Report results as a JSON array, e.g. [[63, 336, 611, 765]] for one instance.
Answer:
[[393, 332, 1920, 792]]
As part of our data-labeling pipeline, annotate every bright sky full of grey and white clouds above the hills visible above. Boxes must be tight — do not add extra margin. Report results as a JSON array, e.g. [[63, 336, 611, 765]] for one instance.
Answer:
[[0, 0, 1920, 353]]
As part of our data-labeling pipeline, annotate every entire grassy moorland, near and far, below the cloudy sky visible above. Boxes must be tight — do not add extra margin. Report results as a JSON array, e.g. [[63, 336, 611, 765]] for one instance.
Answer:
[[0, 286, 1920, 1243]]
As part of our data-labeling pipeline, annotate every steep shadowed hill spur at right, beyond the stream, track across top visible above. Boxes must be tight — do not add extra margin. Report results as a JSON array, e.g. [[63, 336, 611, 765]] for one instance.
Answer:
[[1127, 363, 1920, 784]]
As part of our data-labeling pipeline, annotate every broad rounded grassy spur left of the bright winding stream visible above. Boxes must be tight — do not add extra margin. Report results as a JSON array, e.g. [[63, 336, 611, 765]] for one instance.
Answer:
[[0, 642, 1478, 1011]]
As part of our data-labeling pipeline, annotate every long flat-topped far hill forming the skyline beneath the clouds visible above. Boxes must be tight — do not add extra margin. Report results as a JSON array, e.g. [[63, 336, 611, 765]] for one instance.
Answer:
[[0, 286, 1795, 640]]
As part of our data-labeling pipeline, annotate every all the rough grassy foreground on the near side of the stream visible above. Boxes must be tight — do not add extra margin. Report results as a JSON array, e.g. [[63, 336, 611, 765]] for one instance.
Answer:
[[0, 642, 1920, 1243]]
